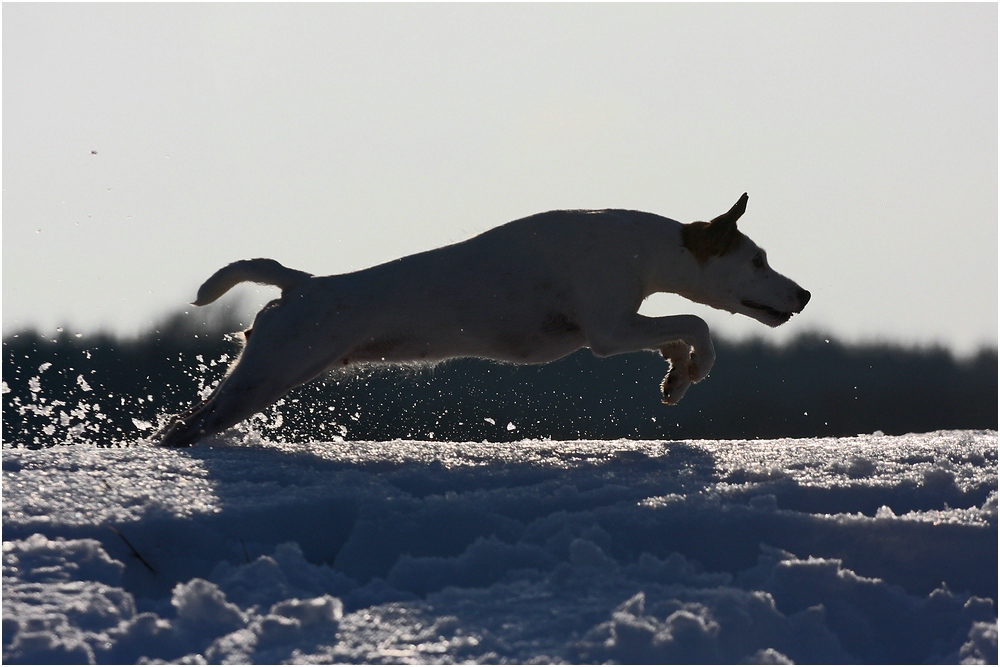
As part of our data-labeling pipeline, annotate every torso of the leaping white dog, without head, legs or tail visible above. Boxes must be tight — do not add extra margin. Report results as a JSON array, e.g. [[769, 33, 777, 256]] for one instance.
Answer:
[[302, 211, 679, 363]]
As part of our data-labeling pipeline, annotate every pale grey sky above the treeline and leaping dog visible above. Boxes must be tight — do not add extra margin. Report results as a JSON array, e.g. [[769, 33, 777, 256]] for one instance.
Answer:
[[3, 3, 998, 353]]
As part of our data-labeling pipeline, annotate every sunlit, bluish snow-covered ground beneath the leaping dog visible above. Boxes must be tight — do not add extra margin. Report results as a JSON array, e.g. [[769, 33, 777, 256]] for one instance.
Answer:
[[3, 431, 997, 664]]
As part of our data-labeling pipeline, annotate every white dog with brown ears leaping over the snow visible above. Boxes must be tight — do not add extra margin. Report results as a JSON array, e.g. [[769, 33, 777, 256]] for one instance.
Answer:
[[160, 193, 810, 447]]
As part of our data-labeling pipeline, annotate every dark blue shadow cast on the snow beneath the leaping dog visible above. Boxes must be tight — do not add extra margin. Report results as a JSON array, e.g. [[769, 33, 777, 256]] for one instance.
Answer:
[[102, 441, 718, 597]]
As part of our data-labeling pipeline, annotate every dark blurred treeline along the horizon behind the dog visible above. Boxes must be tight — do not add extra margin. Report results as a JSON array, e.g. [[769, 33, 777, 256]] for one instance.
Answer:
[[3, 313, 998, 447]]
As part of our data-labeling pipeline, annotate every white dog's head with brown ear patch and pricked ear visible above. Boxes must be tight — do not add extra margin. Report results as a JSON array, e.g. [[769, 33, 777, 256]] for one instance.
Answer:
[[681, 193, 810, 327]]
